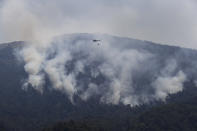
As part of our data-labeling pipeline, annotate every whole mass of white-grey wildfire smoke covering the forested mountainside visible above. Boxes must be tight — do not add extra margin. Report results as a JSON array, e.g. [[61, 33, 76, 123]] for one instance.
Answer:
[[16, 34, 186, 106]]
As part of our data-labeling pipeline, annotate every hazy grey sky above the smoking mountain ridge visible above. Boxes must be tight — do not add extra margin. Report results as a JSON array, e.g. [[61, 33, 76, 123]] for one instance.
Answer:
[[0, 0, 197, 48]]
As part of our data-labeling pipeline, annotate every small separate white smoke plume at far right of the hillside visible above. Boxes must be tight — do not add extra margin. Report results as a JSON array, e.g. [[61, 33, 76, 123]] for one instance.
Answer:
[[153, 60, 186, 101]]
